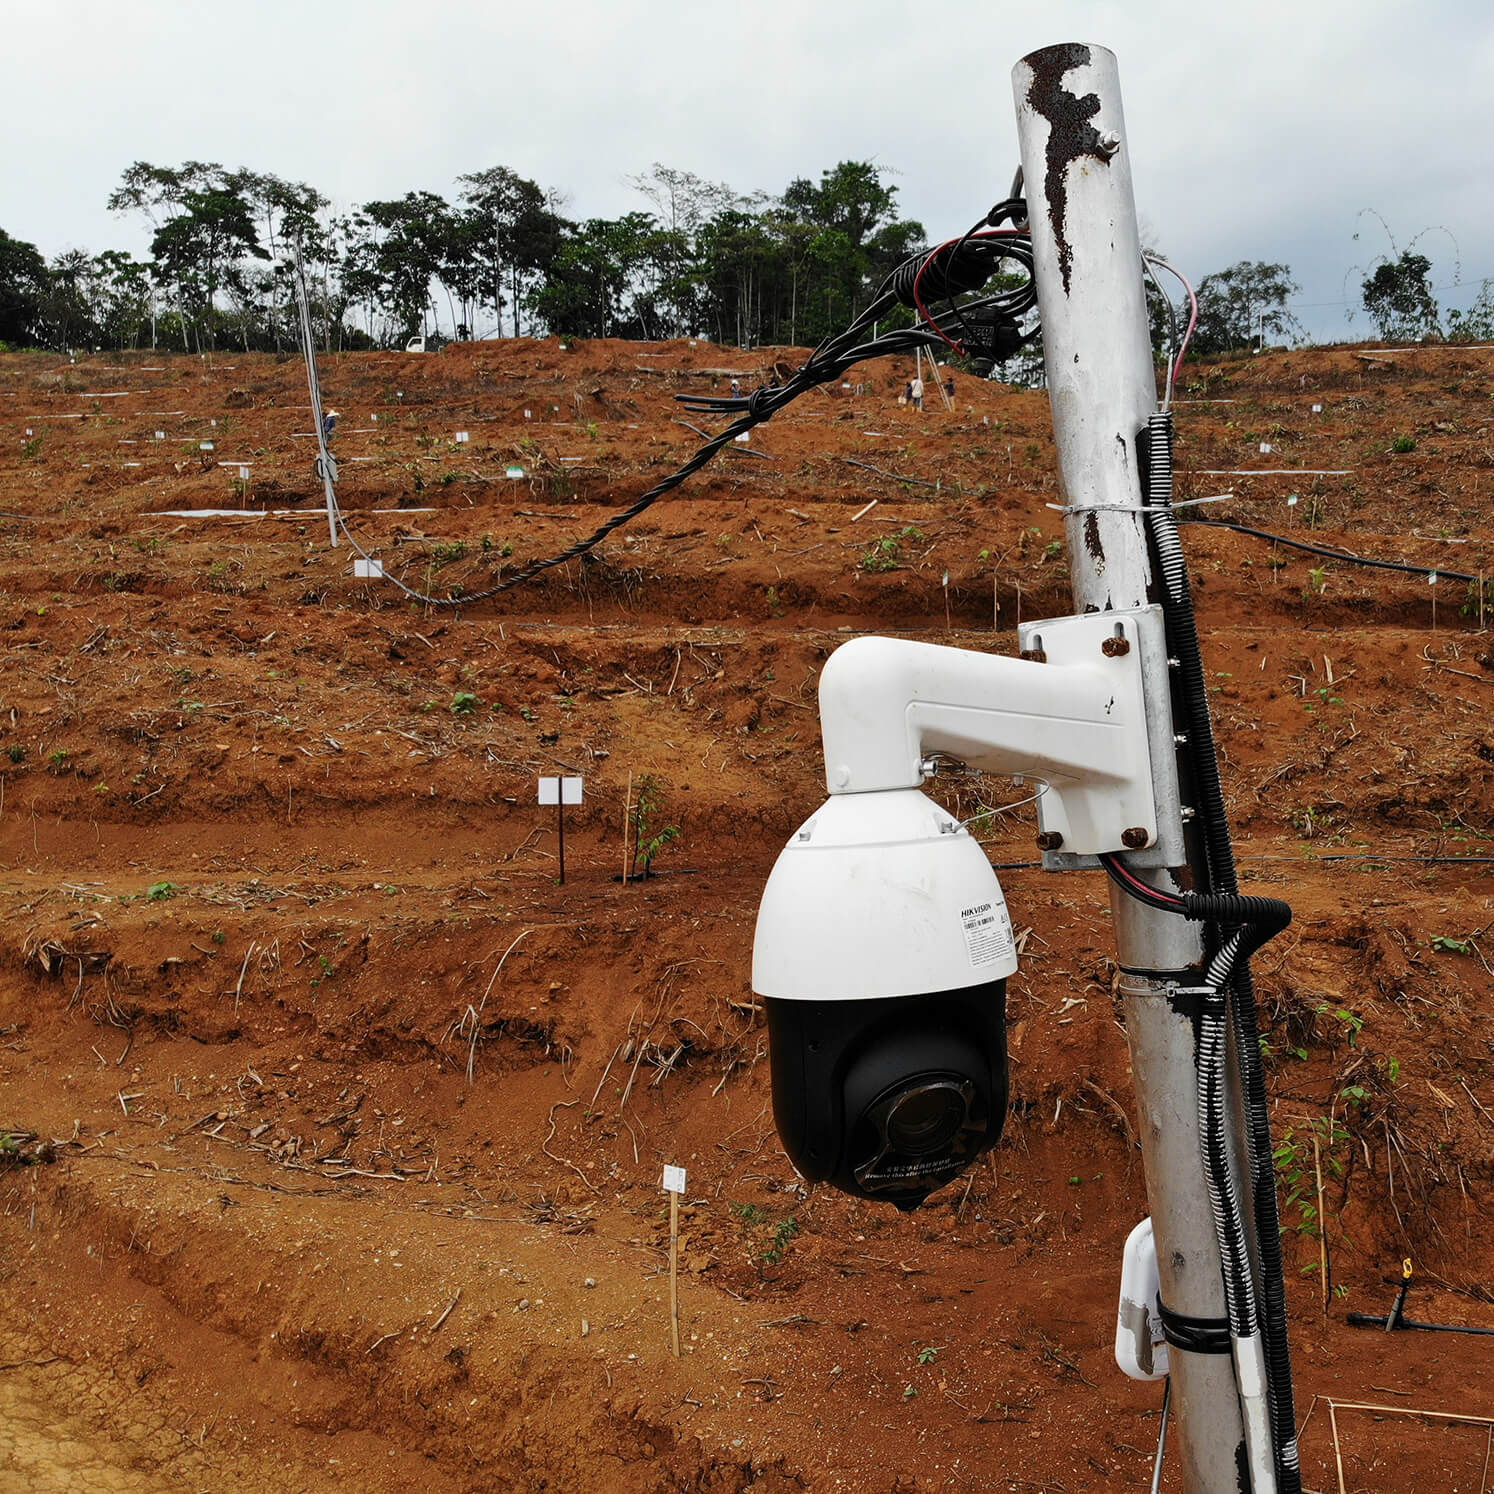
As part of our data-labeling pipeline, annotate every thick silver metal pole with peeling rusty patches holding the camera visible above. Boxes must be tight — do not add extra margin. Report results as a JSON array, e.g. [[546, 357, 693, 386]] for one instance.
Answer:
[[1011, 43, 1264, 1494]]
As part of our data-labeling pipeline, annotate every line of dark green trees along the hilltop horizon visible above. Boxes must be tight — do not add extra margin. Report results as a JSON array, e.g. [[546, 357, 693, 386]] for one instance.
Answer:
[[0, 161, 1470, 354]]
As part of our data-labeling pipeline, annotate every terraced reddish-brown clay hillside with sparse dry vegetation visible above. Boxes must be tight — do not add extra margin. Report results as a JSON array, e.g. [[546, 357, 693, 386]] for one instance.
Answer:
[[0, 341, 1494, 1494]]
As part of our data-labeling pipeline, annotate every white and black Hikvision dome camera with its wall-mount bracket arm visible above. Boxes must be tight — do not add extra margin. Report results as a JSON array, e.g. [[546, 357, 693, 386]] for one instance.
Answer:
[[751, 610, 1176, 1209]]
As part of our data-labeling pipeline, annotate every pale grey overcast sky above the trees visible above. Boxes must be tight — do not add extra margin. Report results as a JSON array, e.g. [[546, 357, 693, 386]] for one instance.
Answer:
[[0, 0, 1494, 336]]
